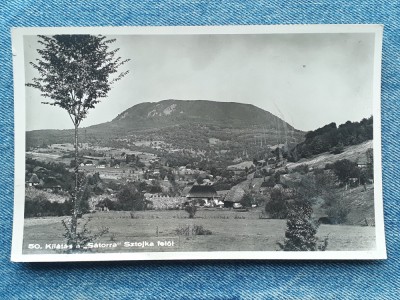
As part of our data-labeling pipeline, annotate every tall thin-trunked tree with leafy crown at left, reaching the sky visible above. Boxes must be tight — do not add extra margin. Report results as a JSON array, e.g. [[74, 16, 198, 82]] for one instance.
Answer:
[[27, 35, 129, 248]]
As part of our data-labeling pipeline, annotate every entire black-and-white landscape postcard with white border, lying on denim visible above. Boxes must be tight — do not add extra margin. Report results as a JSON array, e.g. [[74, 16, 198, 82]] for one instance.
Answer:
[[11, 25, 386, 261]]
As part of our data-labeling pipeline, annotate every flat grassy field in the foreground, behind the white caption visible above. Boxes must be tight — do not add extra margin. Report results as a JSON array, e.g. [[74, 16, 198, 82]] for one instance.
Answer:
[[23, 209, 375, 254]]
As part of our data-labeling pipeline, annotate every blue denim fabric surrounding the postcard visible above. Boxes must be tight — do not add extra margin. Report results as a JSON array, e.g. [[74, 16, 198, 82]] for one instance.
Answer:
[[0, 0, 400, 299]]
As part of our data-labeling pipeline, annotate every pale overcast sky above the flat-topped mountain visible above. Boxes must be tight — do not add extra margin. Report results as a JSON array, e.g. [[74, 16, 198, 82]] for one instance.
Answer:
[[24, 33, 374, 130]]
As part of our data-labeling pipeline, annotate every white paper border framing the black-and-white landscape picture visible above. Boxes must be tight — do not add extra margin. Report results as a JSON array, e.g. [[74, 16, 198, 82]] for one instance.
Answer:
[[11, 24, 387, 262]]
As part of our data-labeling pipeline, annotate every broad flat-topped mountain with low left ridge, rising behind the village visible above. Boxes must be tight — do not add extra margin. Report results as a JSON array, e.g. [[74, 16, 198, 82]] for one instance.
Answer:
[[27, 100, 304, 155]]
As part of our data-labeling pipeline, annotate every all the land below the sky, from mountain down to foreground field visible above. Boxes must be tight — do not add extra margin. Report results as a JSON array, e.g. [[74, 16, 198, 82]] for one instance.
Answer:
[[24, 100, 375, 253]]
